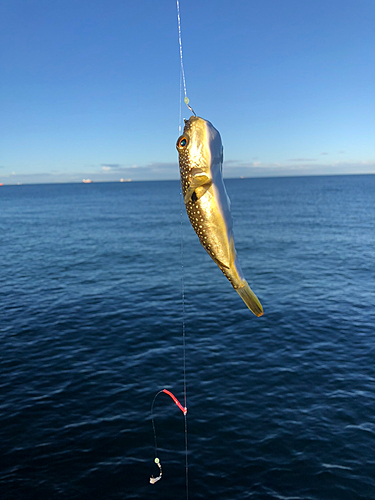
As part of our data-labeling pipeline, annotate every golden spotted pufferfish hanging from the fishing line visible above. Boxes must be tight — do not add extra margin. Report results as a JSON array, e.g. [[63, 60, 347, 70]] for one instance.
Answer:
[[176, 116, 263, 316]]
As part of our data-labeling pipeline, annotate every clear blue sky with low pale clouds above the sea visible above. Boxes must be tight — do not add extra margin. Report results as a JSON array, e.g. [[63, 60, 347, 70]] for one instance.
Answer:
[[0, 0, 375, 184]]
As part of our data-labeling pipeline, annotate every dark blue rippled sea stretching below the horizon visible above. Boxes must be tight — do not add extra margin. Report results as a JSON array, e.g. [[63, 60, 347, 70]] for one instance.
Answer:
[[0, 175, 375, 500]]
